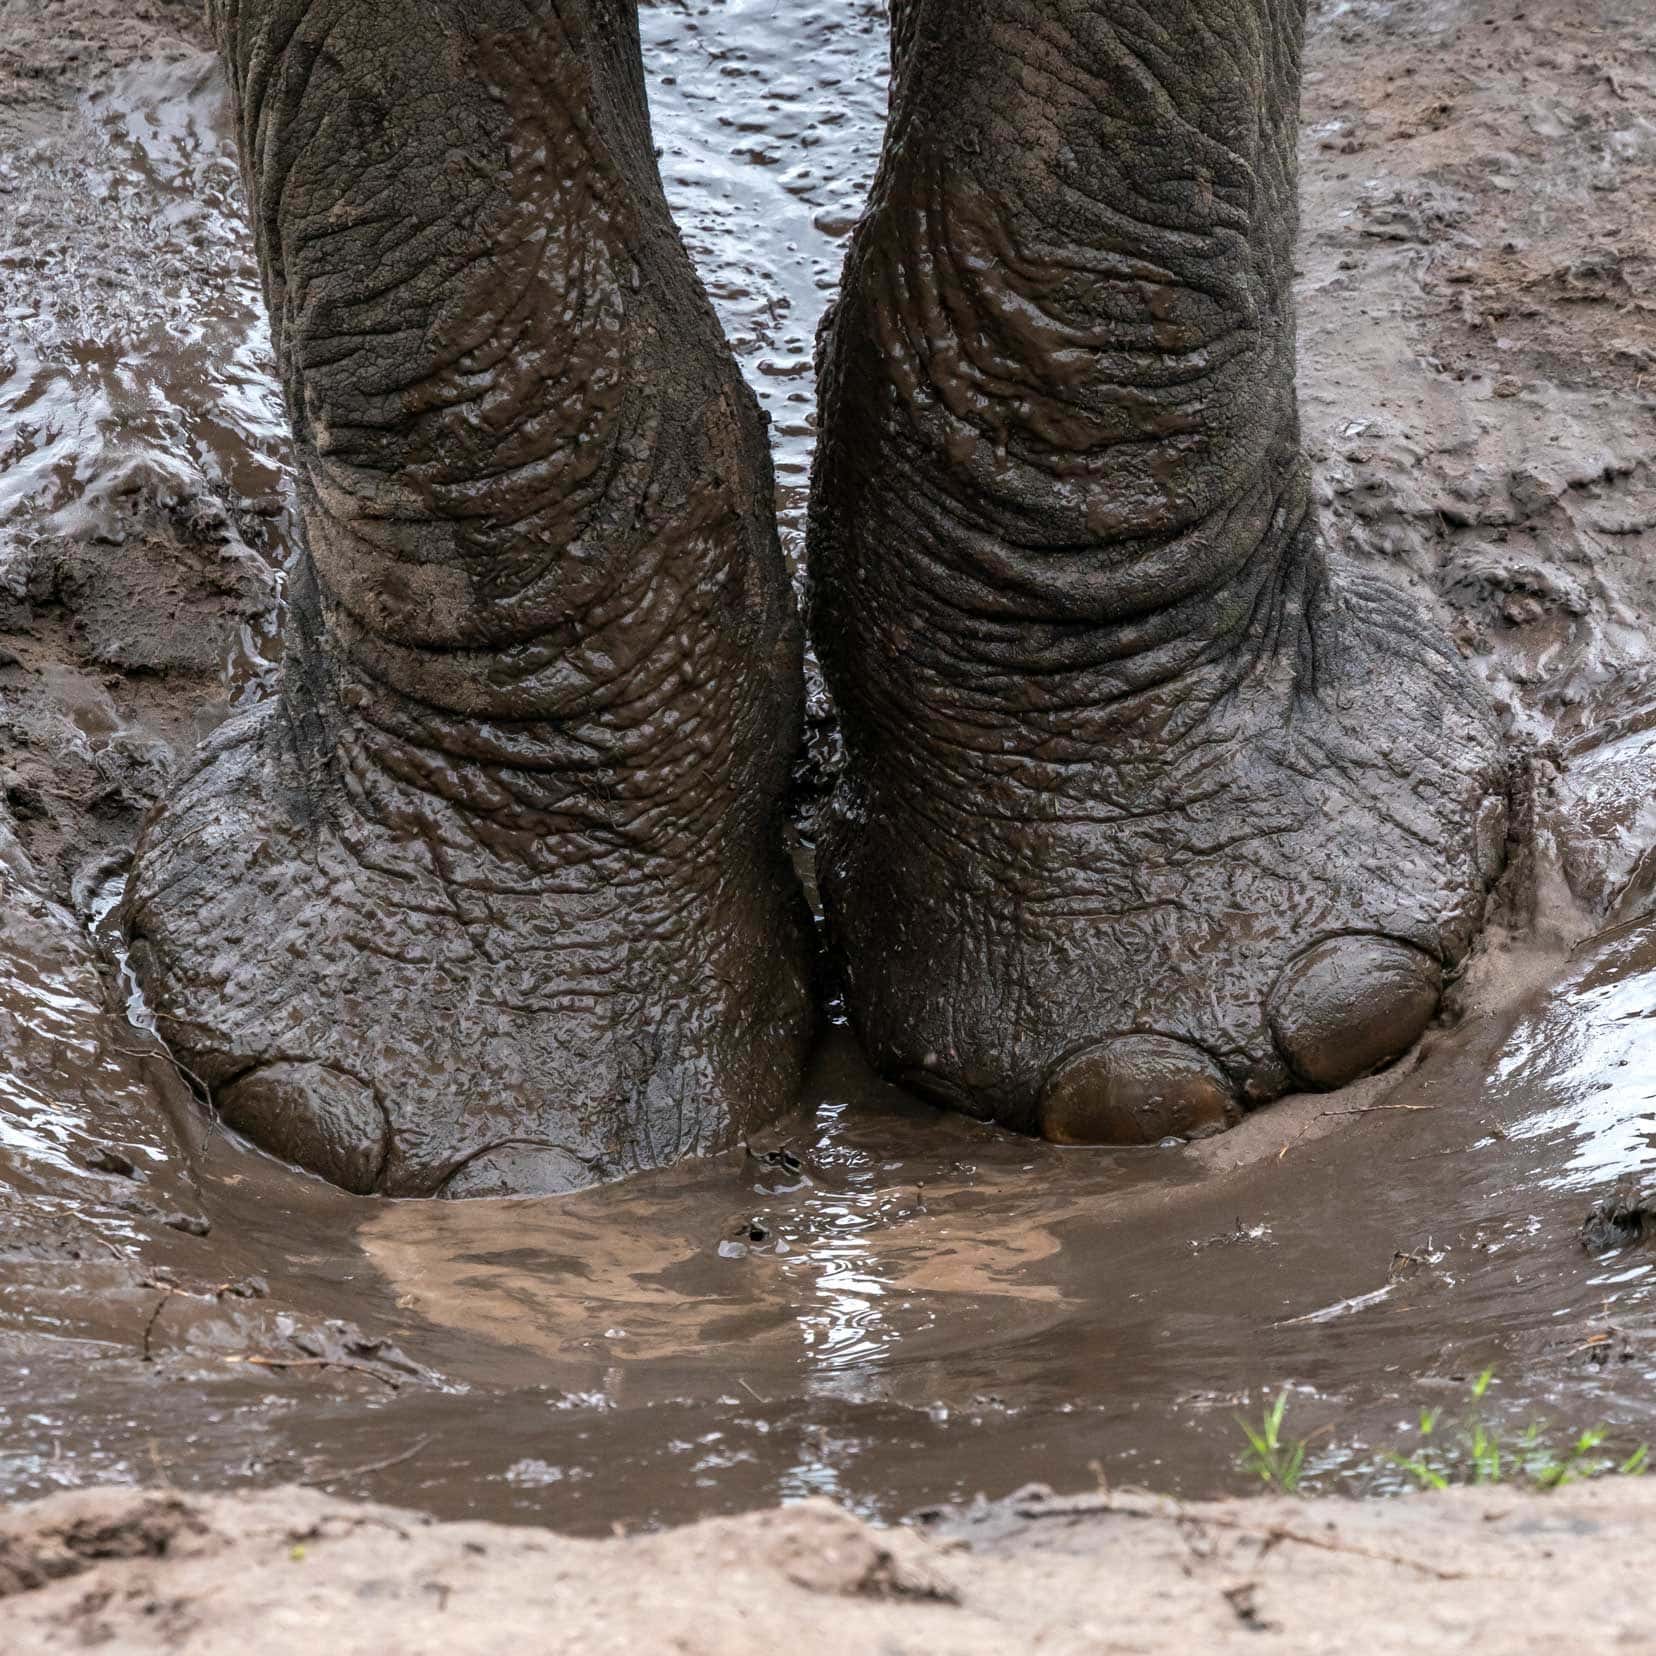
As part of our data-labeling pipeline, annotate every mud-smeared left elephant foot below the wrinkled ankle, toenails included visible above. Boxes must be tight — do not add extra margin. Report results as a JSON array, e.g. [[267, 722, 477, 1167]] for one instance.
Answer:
[[126, 678, 810, 1196]]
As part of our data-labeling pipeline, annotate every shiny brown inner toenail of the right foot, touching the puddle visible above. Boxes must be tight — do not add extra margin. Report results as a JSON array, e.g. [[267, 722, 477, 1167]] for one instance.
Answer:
[[1038, 1035, 1240, 1144]]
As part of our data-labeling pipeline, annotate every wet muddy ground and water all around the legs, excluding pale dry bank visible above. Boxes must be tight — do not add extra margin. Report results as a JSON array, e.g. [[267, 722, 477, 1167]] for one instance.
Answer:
[[0, 0, 1656, 1532]]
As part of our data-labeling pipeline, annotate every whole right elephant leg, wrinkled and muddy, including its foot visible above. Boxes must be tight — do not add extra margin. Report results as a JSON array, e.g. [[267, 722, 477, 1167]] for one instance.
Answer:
[[810, 0, 1505, 1143]]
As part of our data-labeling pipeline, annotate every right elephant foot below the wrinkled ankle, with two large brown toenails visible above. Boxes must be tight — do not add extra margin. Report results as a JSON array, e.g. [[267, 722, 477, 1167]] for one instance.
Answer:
[[821, 556, 1505, 1144]]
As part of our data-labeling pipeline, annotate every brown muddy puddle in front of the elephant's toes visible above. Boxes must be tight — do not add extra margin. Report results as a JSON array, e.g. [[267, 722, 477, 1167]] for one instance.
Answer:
[[0, 929, 1656, 1532]]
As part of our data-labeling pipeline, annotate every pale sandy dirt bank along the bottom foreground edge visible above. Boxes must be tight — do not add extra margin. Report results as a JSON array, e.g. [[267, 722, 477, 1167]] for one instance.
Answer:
[[0, 1482, 1656, 1656]]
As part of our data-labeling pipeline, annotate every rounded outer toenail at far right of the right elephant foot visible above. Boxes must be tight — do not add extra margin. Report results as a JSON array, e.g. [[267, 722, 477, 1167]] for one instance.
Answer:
[[1267, 937, 1444, 1088]]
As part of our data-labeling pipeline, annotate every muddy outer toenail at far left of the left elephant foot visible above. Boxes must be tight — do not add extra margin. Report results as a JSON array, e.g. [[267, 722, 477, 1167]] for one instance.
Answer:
[[214, 1061, 386, 1196]]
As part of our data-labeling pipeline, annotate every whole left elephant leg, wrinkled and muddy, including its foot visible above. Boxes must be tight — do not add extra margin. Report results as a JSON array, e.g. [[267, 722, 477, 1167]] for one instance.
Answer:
[[124, 0, 810, 1194]]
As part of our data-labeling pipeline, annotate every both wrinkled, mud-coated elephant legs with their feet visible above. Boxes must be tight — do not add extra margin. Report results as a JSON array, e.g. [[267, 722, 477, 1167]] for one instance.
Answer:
[[126, 0, 1504, 1194]]
